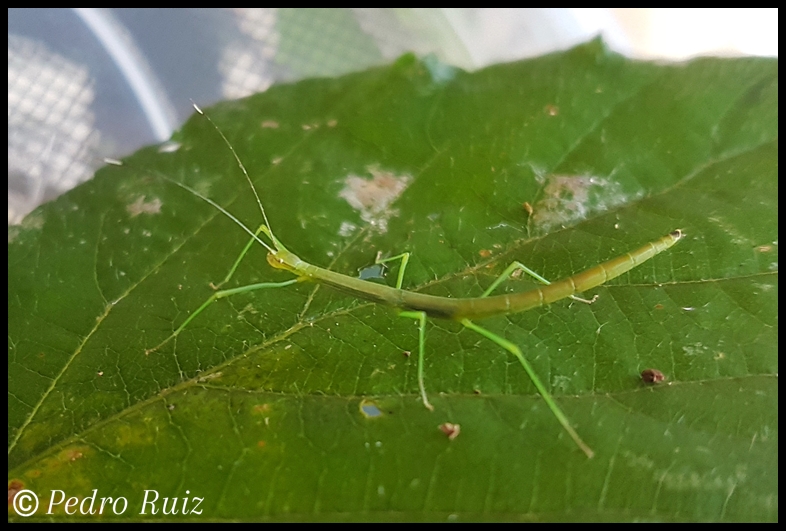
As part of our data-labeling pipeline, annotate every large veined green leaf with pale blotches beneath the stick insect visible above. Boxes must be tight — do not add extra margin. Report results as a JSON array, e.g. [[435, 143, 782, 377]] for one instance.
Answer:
[[8, 41, 778, 520]]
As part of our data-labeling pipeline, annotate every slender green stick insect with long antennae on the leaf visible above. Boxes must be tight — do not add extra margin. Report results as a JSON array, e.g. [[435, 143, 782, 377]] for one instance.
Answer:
[[146, 105, 683, 458]]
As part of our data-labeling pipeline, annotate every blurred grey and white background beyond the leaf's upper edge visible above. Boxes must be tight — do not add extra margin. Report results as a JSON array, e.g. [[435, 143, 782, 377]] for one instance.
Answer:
[[8, 8, 778, 224]]
